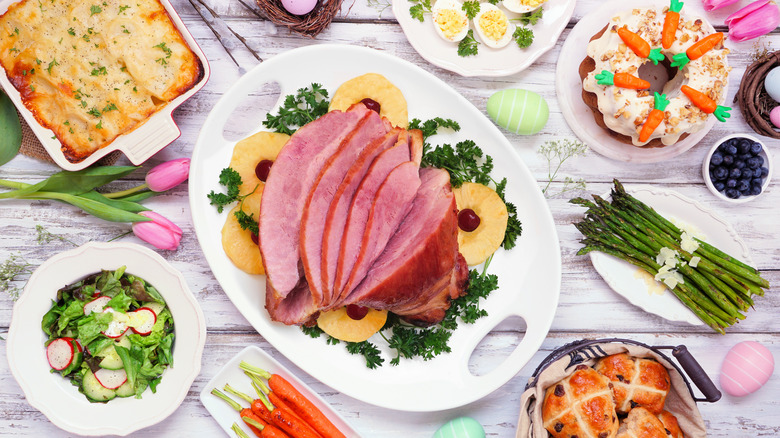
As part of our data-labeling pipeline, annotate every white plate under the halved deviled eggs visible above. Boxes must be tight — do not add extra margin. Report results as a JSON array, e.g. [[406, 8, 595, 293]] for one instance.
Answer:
[[393, 0, 576, 76]]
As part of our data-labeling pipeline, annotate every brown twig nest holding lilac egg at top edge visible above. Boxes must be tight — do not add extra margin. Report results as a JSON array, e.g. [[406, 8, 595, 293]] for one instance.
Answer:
[[255, 0, 342, 38]]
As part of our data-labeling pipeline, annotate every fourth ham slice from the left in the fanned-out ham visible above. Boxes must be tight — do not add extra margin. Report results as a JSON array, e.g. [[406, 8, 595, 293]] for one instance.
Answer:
[[333, 135, 411, 303]]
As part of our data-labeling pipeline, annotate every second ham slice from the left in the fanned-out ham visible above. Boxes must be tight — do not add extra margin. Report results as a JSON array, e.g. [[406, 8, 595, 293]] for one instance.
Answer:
[[300, 111, 387, 305]]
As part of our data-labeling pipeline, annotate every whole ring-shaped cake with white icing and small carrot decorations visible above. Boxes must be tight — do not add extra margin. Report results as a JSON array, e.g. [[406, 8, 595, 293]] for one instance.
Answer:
[[580, 0, 731, 147]]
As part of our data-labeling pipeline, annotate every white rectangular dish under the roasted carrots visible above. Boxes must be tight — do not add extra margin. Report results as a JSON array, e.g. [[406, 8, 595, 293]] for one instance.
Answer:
[[200, 345, 360, 438]]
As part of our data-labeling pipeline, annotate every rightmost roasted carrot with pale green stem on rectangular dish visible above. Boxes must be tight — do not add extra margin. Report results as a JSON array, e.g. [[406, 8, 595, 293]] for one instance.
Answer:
[[239, 362, 345, 438]]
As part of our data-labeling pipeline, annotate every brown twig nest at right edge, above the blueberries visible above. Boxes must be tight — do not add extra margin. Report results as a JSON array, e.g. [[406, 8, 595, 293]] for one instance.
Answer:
[[734, 51, 780, 138]]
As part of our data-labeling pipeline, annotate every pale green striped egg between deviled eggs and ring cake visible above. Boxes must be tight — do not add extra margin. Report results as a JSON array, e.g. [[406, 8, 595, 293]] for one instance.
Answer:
[[487, 88, 550, 135]]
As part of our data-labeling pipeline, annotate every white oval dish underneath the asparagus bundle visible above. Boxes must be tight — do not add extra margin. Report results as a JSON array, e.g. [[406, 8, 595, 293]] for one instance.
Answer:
[[589, 188, 752, 325]]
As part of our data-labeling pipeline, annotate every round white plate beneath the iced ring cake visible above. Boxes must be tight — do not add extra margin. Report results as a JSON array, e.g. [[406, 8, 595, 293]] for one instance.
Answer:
[[555, 0, 716, 163]]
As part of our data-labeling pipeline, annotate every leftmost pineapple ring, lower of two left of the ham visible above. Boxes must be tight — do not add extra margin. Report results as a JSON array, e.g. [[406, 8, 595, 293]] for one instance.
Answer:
[[222, 192, 265, 274]]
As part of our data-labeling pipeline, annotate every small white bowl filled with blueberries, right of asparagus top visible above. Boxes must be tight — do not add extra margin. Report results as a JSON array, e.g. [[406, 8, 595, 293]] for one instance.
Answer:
[[702, 134, 772, 203]]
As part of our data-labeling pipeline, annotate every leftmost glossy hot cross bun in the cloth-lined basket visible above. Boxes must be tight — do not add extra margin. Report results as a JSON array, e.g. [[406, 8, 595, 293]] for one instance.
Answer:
[[542, 365, 618, 438]]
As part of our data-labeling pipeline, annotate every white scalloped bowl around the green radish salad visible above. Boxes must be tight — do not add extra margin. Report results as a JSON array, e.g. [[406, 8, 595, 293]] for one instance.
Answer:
[[7, 242, 206, 436]]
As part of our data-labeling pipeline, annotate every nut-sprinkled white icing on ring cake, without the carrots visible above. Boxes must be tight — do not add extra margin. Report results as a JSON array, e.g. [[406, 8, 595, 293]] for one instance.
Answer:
[[583, 8, 731, 146]]
